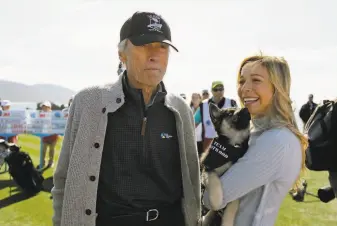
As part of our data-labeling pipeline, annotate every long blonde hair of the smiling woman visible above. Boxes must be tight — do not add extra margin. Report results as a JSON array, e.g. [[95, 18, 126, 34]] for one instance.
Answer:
[[238, 54, 308, 185]]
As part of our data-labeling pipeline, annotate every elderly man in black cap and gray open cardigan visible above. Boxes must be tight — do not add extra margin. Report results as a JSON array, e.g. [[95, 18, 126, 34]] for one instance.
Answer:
[[52, 12, 201, 226]]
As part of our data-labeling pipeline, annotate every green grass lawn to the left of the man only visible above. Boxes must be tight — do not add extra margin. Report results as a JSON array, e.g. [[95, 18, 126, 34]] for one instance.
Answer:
[[0, 135, 61, 226]]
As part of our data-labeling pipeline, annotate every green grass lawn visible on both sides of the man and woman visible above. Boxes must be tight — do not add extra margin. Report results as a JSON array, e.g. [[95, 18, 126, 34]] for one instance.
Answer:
[[0, 135, 337, 226]]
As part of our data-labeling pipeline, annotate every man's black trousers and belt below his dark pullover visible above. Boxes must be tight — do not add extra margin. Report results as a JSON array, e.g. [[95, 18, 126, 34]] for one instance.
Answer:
[[96, 205, 185, 226]]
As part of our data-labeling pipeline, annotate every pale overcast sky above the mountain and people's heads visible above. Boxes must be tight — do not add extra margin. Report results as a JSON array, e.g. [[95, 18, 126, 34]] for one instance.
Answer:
[[0, 0, 337, 104]]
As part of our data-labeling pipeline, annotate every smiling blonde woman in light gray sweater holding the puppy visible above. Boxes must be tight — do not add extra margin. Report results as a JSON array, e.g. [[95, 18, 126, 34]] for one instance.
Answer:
[[204, 56, 307, 226]]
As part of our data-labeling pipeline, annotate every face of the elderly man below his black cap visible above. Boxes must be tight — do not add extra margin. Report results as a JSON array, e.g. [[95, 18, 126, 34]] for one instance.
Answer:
[[121, 41, 169, 87]]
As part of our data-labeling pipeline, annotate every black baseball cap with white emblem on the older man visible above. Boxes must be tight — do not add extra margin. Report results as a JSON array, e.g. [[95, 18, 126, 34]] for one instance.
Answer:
[[120, 12, 178, 52]]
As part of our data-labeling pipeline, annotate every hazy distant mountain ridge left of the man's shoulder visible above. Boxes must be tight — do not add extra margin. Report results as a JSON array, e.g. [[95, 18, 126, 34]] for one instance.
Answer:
[[0, 80, 76, 103]]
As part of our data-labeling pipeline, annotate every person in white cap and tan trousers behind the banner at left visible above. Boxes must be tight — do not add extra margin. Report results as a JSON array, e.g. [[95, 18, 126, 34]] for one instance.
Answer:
[[41, 101, 59, 168]]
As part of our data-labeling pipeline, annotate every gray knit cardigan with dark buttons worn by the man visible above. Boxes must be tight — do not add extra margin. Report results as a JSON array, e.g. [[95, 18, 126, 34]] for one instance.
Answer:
[[51, 76, 201, 226]]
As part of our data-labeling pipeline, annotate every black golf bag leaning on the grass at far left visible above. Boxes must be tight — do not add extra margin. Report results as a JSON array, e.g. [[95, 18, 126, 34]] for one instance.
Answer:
[[5, 144, 44, 195]]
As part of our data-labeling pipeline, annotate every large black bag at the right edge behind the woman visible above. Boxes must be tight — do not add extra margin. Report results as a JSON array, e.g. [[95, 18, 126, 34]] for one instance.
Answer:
[[304, 101, 337, 171]]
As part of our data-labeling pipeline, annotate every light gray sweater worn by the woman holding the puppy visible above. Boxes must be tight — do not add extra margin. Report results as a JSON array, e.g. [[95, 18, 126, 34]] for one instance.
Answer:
[[204, 124, 302, 226]]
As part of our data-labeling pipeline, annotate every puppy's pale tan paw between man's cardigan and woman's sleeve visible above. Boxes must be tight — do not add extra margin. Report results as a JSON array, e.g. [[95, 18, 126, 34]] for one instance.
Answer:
[[208, 173, 223, 210]]
